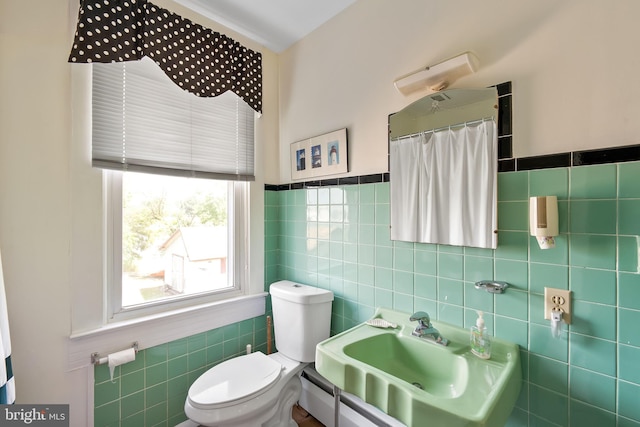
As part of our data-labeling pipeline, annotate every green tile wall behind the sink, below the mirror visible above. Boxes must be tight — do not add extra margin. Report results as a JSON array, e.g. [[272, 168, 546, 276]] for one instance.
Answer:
[[265, 162, 640, 427]]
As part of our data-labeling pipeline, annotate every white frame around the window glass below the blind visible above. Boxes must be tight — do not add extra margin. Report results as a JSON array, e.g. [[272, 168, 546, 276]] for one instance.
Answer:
[[103, 170, 249, 323]]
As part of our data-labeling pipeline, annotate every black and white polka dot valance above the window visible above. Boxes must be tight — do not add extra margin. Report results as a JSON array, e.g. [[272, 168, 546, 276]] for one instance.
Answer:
[[69, 0, 262, 113]]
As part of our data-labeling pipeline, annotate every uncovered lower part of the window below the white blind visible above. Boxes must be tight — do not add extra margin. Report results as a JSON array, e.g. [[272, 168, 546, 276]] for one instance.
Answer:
[[105, 171, 248, 319]]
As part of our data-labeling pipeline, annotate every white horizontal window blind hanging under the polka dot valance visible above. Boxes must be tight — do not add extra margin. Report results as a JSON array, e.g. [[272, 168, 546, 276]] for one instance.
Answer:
[[92, 58, 255, 181]]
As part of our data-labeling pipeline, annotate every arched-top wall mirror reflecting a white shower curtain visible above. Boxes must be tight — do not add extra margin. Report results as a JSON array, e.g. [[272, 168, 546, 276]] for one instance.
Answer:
[[389, 87, 498, 249]]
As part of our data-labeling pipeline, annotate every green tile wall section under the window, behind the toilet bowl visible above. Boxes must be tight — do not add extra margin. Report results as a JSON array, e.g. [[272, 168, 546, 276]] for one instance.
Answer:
[[94, 316, 266, 427]]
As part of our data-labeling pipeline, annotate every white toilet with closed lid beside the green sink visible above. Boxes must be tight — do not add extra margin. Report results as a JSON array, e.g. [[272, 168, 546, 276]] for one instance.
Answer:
[[184, 280, 333, 427]]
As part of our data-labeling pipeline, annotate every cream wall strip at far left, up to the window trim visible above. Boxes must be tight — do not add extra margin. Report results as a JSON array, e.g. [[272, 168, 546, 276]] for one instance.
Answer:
[[0, 0, 76, 412]]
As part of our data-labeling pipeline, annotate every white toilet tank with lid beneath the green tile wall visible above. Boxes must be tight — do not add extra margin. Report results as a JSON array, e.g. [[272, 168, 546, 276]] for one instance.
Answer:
[[269, 280, 333, 363]]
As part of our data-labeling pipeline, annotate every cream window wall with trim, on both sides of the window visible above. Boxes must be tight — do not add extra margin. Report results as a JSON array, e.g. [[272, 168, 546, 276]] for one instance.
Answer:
[[0, 0, 278, 426]]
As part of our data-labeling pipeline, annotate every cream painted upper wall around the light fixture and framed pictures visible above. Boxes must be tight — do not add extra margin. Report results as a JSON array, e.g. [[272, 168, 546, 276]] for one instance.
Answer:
[[280, 0, 640, 183]]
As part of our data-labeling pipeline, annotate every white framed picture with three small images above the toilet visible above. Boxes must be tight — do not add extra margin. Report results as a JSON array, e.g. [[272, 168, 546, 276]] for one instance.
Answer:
[[291, 128, 349, 180]]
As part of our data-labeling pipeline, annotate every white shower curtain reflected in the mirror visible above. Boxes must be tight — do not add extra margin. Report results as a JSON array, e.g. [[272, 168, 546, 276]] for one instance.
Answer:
[[390, 120, 498, 248]]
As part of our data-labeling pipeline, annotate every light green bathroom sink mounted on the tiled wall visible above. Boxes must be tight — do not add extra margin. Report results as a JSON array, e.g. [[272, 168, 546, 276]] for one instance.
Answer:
[[315, 309, 522, 427]]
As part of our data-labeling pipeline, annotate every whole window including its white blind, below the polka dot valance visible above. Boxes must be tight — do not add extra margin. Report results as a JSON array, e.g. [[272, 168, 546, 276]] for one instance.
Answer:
[[92, 59, 255, 320]]
